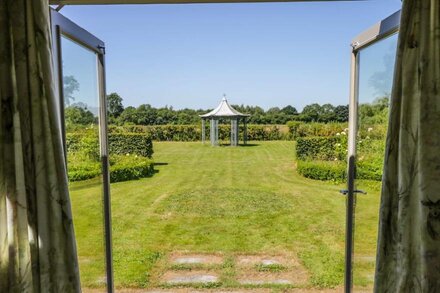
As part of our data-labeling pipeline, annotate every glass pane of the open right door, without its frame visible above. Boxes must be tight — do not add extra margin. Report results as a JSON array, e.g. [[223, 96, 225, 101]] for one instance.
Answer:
[[353, 34, 397, 288]]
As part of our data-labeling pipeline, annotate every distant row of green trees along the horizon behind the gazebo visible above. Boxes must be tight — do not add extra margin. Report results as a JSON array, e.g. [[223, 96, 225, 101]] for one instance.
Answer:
[[66, 93, 388, 125]]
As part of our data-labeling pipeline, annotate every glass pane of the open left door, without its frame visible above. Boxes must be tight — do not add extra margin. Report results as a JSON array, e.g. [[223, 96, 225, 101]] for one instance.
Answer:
[[61, 37, 106, 291]]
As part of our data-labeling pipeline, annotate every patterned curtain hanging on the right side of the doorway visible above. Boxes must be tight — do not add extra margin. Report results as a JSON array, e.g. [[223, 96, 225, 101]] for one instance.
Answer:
[[375, 0, 440, 293]]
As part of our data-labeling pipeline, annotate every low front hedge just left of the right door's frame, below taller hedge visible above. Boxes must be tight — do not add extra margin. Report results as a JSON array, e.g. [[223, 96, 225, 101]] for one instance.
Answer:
[[297, 161, 347, 182]]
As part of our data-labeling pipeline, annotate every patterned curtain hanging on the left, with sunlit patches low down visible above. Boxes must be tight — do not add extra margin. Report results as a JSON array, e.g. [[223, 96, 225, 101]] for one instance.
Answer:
[[0, 0, 80, 293]]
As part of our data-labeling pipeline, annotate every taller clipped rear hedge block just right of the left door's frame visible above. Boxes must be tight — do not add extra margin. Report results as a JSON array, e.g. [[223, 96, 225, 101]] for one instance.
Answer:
[[108, 133, 153, 158]]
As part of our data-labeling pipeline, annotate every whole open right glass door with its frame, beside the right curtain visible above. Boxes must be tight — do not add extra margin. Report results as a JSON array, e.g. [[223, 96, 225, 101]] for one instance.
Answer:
[[345, 11, 400, 292]]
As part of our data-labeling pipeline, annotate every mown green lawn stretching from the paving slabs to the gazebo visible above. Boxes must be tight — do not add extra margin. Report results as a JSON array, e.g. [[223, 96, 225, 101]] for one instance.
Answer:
[[71, 141, 379, 287]]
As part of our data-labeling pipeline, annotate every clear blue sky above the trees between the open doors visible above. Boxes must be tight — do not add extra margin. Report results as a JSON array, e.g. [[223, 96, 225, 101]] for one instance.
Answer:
[[61, 0, 401, 110]]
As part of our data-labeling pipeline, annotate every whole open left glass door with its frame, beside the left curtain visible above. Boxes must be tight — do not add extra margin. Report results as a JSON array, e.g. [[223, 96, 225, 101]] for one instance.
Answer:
[[51, 10, 113, 292]]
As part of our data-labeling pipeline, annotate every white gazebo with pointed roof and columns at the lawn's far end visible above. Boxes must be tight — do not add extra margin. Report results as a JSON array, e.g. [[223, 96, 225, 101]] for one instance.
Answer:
[[200, 95, 250, 146]]
